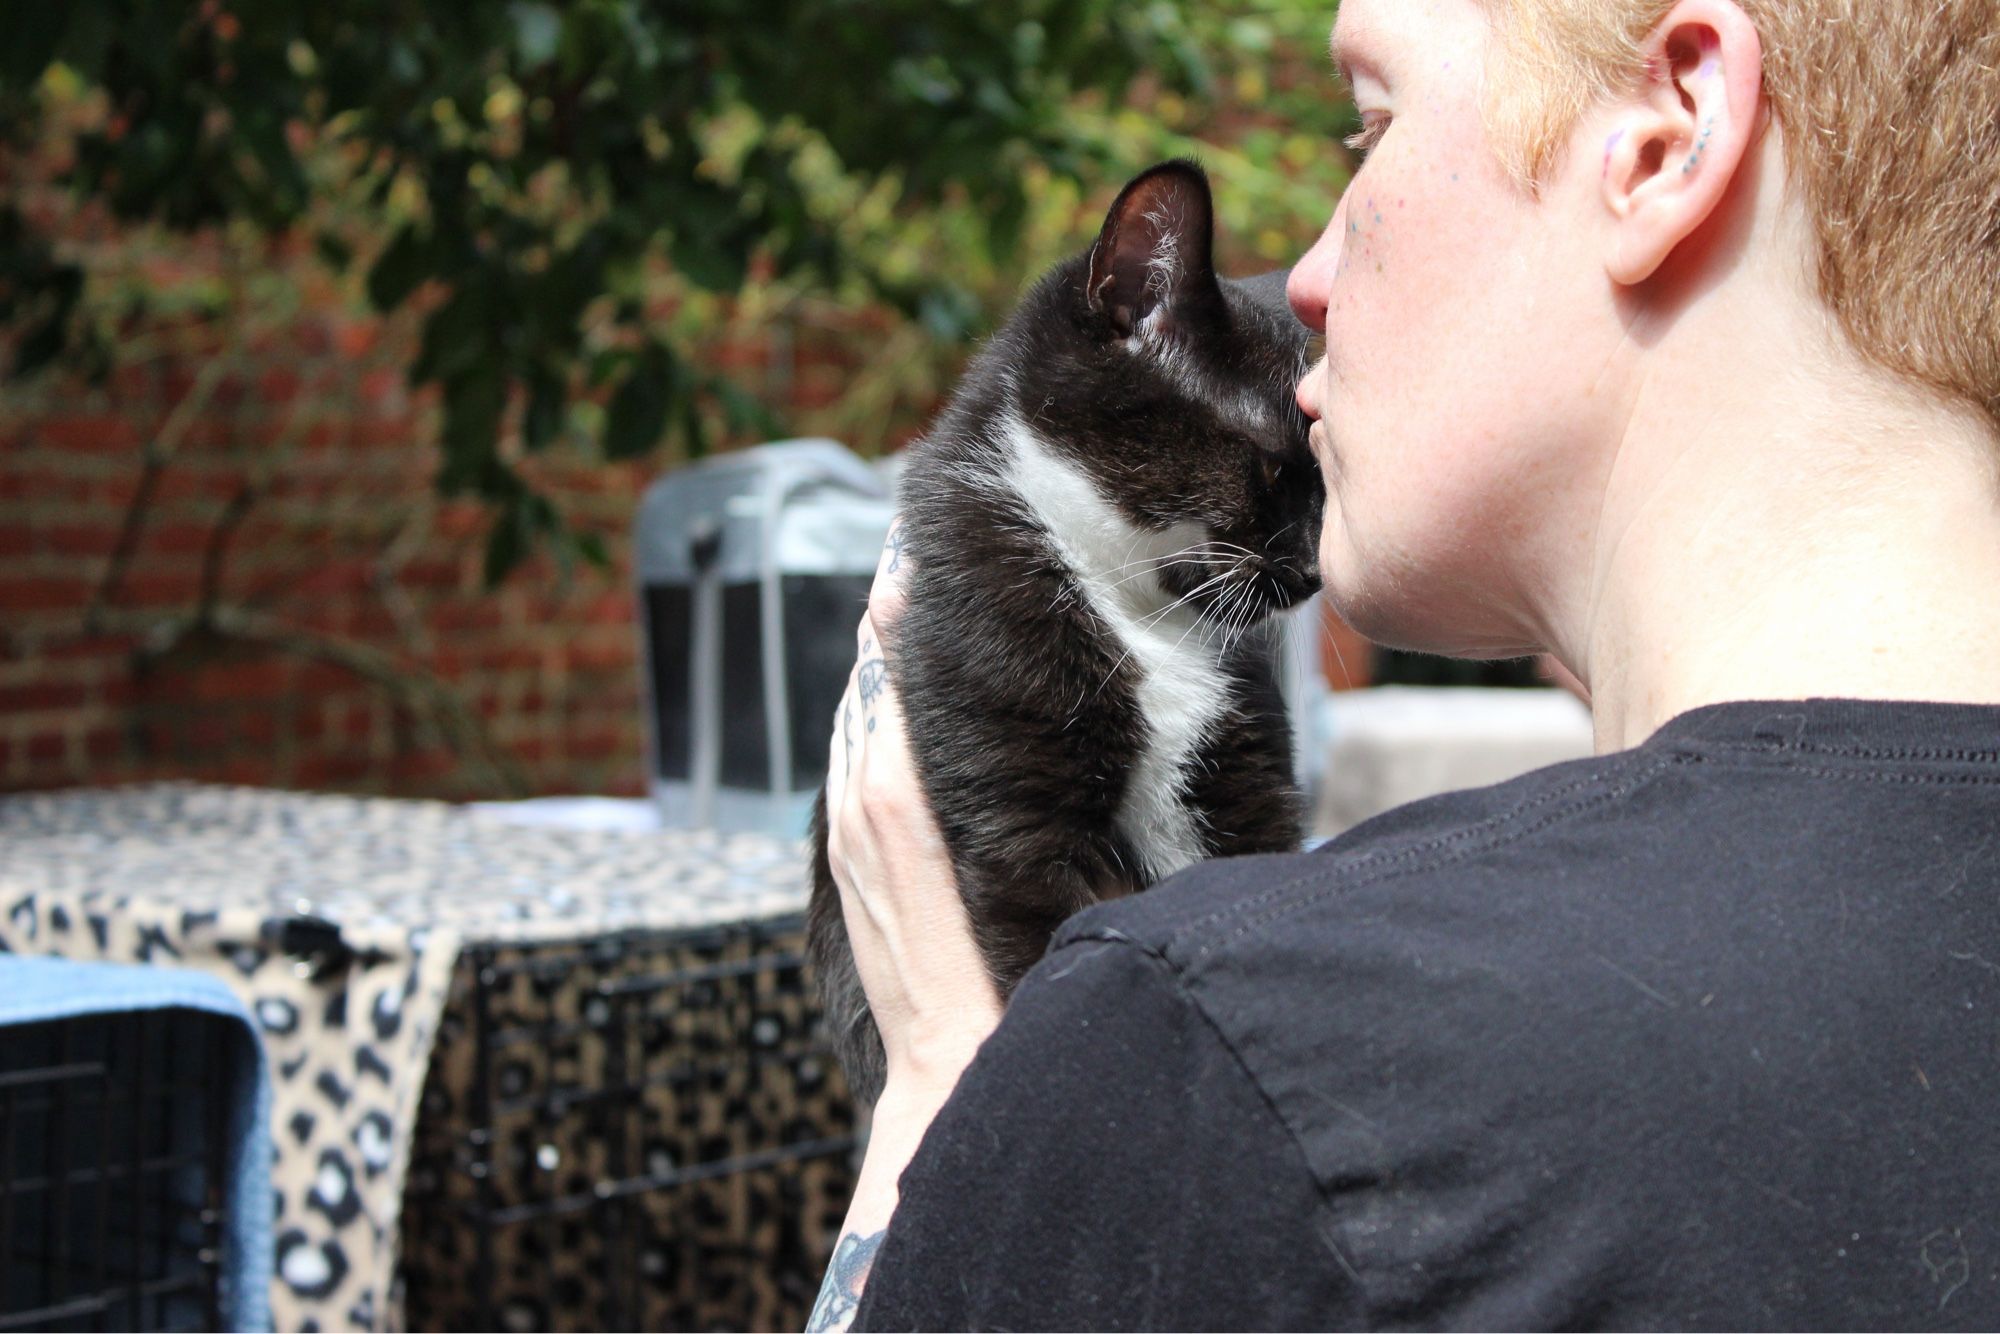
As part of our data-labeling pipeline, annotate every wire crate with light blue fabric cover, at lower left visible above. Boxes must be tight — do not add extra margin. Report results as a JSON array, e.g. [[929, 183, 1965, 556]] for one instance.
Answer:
[[0, 958, 270, 1330]]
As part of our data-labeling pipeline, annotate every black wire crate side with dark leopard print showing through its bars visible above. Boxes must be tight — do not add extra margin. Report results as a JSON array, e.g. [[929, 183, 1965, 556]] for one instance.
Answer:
[[402, 914, 856, 1330]]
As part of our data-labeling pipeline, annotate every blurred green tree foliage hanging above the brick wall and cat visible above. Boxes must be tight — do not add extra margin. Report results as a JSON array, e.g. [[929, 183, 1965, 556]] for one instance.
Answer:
[[0, 0, 1344, 578]]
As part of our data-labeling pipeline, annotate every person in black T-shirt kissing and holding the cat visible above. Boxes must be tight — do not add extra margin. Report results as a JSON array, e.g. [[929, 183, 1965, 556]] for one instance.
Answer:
[[816, 0, 2000, 1328]]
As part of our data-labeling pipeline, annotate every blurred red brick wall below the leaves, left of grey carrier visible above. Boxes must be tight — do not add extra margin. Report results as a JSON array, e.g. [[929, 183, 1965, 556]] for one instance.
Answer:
[[0, 280, 676, 796]]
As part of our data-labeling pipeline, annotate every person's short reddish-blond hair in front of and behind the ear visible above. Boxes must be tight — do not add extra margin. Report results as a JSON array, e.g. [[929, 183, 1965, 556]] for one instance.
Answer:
[[1484, 0, 2000, 426]]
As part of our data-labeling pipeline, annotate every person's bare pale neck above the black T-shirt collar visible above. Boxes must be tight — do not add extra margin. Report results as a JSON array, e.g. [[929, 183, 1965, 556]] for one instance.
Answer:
[[1558, 328, 2000, 752]]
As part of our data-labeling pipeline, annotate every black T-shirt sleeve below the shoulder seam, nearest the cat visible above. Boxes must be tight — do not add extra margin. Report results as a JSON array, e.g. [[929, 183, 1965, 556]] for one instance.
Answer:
[[856, 940, 1358, 1330]]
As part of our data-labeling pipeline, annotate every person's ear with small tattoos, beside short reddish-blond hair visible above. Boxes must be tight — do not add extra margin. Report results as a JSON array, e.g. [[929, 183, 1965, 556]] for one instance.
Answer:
[[1598, 0, 1764, 286]]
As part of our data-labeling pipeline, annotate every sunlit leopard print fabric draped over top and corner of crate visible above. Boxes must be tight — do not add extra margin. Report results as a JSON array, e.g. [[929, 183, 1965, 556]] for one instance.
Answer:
[[0, 784, 852, 1330]]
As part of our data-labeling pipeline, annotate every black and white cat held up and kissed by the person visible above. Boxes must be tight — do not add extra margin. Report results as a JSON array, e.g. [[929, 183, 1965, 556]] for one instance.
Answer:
[[808, 162, 1324, 1100]]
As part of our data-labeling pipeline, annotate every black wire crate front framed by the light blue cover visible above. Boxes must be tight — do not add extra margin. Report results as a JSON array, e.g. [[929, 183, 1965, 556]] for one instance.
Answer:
[[0, 1010, 234, 1330]]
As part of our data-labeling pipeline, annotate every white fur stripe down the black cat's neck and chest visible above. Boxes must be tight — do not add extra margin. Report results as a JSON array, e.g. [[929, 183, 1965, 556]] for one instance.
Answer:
[[1002, 416, 1230, 880]]
